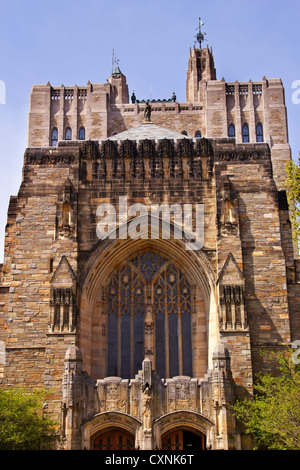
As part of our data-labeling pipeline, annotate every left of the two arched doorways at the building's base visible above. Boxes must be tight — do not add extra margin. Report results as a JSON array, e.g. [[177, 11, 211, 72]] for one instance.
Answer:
[[92, 428, 134, 451]]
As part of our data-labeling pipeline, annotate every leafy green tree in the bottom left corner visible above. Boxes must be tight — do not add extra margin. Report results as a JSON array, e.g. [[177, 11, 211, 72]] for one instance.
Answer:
[[0, 388, 56, 450]]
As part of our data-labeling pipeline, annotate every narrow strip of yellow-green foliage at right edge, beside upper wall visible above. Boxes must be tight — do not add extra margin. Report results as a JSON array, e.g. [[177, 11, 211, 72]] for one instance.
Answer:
[[285, 159, 300, 249]]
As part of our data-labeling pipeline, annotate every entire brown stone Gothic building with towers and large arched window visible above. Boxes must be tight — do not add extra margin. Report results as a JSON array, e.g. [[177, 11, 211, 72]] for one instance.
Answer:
[[0, 34, 300, 450]]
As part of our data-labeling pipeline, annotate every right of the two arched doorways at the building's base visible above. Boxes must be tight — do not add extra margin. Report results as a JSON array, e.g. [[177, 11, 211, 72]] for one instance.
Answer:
[[162, 429, 206, 452]]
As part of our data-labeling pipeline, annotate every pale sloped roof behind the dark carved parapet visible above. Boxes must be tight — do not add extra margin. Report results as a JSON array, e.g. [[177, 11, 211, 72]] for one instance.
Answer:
[[108, 122, 189, 141]]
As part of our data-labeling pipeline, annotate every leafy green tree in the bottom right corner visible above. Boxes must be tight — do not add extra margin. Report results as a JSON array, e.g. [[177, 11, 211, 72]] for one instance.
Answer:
[[234, 351, 300, 450]]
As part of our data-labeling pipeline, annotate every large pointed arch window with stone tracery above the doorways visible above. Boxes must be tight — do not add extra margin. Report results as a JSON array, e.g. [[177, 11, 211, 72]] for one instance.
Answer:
[[105, 251, 192, 378]]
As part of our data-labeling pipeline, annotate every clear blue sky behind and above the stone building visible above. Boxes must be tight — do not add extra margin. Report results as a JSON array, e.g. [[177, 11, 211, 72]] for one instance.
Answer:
[[0, 0, 300, 262]]
